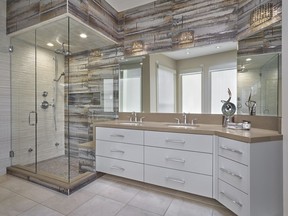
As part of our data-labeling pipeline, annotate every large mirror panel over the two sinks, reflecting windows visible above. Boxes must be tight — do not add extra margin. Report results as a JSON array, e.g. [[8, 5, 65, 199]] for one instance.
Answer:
[[119, 42, 237, 114]]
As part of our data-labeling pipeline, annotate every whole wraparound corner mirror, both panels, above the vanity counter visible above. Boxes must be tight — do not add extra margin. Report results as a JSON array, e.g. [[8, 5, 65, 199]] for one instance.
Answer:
[[119, 27, 281, 116]]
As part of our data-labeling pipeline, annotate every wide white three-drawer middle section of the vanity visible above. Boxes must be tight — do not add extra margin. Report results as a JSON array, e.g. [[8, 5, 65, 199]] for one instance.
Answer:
[[144, 131, 213, 197]]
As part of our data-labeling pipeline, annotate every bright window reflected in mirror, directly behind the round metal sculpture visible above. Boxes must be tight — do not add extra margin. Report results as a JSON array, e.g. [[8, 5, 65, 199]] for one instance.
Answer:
[[209, 69, 237, 114]]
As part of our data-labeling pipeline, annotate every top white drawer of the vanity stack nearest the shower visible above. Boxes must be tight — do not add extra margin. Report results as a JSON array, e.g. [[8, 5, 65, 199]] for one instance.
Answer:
[[96, 127, 143, 145]]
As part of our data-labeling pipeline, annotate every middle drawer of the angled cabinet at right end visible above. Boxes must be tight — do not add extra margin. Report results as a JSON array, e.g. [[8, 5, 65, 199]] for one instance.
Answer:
[[218, 157, 249, 194]]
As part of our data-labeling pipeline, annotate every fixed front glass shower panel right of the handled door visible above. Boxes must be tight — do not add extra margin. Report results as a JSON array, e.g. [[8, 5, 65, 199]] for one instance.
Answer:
[[36, 18, 70, 182]]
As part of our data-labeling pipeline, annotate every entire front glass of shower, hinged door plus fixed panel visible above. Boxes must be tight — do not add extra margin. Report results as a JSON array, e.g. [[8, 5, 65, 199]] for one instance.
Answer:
[[11, 18, 68, 183]]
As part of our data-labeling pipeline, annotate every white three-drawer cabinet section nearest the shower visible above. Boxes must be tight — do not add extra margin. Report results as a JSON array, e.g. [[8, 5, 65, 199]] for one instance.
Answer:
[[96, 127, 144, 181]]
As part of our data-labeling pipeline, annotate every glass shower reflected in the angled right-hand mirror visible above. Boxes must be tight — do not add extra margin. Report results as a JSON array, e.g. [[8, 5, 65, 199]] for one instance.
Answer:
[[237, 53, 280, 116]]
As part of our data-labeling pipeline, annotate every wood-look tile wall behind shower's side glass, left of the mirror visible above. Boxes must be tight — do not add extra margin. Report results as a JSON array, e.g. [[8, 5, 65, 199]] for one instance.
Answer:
[[65, 51, 119, 172]]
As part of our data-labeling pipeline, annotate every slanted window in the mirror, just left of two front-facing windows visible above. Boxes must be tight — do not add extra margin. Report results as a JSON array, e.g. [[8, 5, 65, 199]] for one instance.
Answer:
[[157, 65, 176, 113]]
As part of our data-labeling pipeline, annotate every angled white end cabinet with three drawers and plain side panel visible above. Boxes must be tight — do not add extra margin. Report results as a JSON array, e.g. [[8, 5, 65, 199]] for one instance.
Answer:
[[217, 137, 283, 216]]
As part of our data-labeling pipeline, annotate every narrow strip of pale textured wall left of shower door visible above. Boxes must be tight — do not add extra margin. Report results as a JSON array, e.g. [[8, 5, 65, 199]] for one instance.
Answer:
[[0, 1, 10, 176]]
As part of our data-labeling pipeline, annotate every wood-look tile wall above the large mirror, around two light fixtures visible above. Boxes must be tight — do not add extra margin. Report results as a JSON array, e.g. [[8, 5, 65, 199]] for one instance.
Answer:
[[120, 0, 238, 55]]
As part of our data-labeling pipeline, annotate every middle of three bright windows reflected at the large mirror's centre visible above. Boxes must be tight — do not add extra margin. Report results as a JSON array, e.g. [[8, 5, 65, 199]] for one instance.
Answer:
[[180, 72, 202, 113]]
